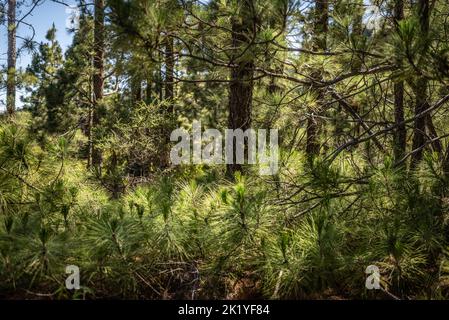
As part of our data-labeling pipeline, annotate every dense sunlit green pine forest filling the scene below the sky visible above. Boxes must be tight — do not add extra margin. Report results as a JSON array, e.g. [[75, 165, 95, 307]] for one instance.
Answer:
[[4, 0, 449, 299]]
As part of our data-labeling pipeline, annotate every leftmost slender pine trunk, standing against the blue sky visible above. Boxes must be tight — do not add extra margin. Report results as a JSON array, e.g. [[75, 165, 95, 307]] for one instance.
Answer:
[[6, 0, 17, 115]]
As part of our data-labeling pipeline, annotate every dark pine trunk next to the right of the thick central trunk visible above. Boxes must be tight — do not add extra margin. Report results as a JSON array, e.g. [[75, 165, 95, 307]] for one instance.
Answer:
[[306, 0, 329, 156]]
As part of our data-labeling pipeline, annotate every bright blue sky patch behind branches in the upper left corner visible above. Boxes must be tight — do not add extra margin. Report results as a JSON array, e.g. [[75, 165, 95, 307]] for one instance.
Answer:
[[0, 0, 75, 110]]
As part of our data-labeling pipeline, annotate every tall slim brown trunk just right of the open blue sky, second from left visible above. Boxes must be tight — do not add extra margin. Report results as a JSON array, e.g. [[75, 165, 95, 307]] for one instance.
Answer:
[[90, 0, 105, 169]]
